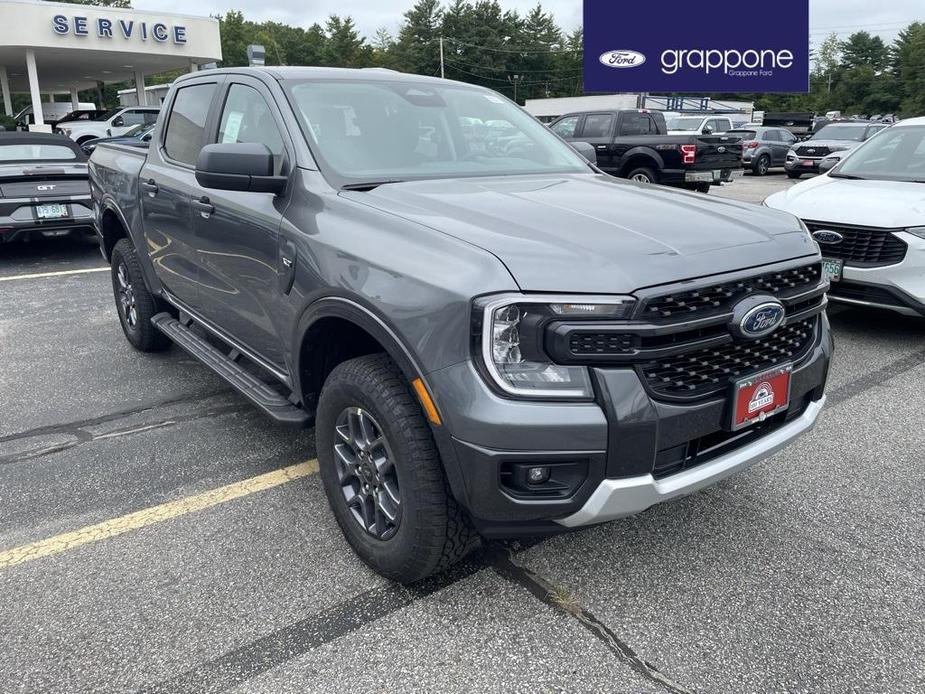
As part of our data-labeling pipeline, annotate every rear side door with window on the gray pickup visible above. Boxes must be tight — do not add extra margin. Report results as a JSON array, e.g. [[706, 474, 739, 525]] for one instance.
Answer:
[[138, 77, 222, 308]]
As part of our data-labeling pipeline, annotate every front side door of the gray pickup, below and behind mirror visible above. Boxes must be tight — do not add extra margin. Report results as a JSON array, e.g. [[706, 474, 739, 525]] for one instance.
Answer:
[[189, 76, 294, 370]]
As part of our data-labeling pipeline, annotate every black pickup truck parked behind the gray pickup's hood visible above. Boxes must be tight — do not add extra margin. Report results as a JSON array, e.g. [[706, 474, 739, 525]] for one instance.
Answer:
[[549, 109, 742, 193]]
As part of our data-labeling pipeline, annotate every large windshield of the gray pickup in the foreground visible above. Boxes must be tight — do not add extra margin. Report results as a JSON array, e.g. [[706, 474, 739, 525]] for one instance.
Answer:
[[284, 80, 588, 185]]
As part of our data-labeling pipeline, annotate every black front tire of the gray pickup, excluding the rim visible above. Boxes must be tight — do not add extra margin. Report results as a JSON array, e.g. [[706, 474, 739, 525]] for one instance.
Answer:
[[315, 354, 478, 583]]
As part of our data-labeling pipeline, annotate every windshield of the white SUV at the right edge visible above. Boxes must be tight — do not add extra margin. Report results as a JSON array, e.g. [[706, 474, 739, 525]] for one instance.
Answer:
[[829, 125, 925, 182]]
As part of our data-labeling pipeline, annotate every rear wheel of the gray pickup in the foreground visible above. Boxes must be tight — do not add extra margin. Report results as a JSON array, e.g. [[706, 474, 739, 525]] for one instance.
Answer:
[[112, 239, 170, 352]]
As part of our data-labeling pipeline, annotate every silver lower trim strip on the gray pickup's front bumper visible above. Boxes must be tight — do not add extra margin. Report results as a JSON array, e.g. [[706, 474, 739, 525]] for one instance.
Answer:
[[556, 396, 825, 528]]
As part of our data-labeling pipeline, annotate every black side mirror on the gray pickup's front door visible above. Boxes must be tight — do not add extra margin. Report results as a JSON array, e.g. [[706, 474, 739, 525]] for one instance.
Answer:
[[196, 142, 287, 195]]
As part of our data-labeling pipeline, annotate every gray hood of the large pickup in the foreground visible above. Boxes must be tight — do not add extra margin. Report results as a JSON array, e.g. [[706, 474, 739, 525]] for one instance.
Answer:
[[341, 174, 816, 293]]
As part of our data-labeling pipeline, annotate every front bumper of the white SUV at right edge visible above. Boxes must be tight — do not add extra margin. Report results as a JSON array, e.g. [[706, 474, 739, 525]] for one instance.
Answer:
[[829, 232, 925, 316]]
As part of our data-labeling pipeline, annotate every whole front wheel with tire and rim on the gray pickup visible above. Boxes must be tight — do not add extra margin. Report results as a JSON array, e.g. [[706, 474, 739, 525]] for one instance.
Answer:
[[315, 354, 476, 583]]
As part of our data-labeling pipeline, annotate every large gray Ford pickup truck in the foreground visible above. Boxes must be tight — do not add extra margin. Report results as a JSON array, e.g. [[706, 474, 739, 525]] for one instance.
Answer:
[[90, 67, 832, 582]]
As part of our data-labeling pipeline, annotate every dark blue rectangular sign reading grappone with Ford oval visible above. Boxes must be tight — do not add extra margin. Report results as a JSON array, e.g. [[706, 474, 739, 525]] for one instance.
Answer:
[[584, 0, 809, 93]]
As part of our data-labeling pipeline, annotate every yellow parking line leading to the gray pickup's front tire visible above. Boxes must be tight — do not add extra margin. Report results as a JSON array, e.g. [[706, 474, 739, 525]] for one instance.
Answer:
[[0, 459, 318, 569]]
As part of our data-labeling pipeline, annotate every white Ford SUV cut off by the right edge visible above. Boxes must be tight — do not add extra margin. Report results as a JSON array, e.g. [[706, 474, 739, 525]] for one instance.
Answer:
[[765, 118, 925, 316]]
